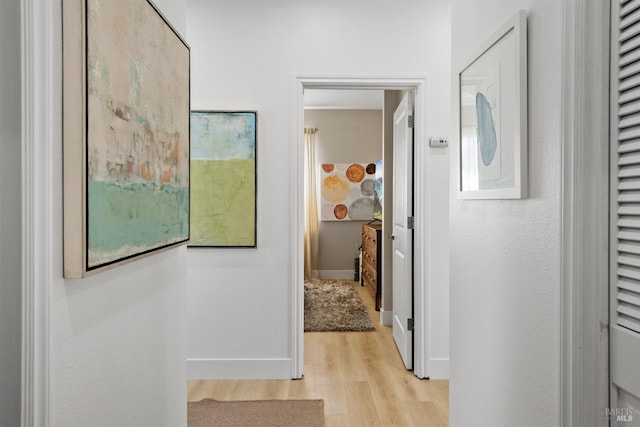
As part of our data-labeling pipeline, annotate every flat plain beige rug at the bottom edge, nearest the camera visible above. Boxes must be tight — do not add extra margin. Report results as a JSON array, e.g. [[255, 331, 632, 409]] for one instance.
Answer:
[[187, 399, 324, 427]]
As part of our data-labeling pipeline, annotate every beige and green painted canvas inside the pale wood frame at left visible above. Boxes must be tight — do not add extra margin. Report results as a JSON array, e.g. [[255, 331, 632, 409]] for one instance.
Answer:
[[86, 0, 190, 268]]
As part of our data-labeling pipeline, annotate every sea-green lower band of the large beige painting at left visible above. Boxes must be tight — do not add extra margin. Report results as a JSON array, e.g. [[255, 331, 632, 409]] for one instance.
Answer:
[[87, 181, 189, 267]]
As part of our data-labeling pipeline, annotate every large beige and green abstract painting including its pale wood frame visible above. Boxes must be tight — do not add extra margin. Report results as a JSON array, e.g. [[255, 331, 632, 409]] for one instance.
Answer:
[[63, 0, 190, 277]]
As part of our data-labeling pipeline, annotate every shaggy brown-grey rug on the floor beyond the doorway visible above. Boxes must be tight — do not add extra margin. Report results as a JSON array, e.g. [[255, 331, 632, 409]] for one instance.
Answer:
[[304, 280, 375, 332]]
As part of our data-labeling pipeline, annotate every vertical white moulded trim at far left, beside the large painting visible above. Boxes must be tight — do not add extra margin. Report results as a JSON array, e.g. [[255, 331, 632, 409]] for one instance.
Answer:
[[21, 0, 53, 427]]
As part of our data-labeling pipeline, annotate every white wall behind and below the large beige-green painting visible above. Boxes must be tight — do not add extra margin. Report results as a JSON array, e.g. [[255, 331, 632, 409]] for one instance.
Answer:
[[36, 0, 187, 427]]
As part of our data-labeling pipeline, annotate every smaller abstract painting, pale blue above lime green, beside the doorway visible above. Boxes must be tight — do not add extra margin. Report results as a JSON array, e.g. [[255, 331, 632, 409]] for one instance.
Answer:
[[189, 111, 257, 248]]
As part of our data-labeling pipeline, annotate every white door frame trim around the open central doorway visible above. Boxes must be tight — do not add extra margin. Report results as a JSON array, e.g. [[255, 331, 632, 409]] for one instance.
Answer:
[[290, 77, 429, 378]]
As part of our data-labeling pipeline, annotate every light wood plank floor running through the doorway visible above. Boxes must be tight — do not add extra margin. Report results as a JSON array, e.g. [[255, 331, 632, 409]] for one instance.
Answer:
[[188, 282, 449, 427]]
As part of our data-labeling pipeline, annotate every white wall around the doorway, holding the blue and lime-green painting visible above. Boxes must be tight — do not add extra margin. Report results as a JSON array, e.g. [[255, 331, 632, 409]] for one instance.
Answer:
[[187, 0, 451, 378]]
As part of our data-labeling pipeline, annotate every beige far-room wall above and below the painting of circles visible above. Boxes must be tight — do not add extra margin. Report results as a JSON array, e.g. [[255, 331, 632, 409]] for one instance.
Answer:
[[304, 110, 382, 279]]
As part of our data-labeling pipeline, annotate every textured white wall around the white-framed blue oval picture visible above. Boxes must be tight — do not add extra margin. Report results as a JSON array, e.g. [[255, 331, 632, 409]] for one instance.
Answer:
[[450, 0, 562, 426]]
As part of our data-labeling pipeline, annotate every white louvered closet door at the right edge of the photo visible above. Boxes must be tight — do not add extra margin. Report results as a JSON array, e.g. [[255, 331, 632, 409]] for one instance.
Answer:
[[610, 0, 640, 426]]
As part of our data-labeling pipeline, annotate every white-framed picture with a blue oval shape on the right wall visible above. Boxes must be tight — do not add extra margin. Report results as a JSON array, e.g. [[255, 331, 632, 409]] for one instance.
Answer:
[[458, 11, 527, 199]]
